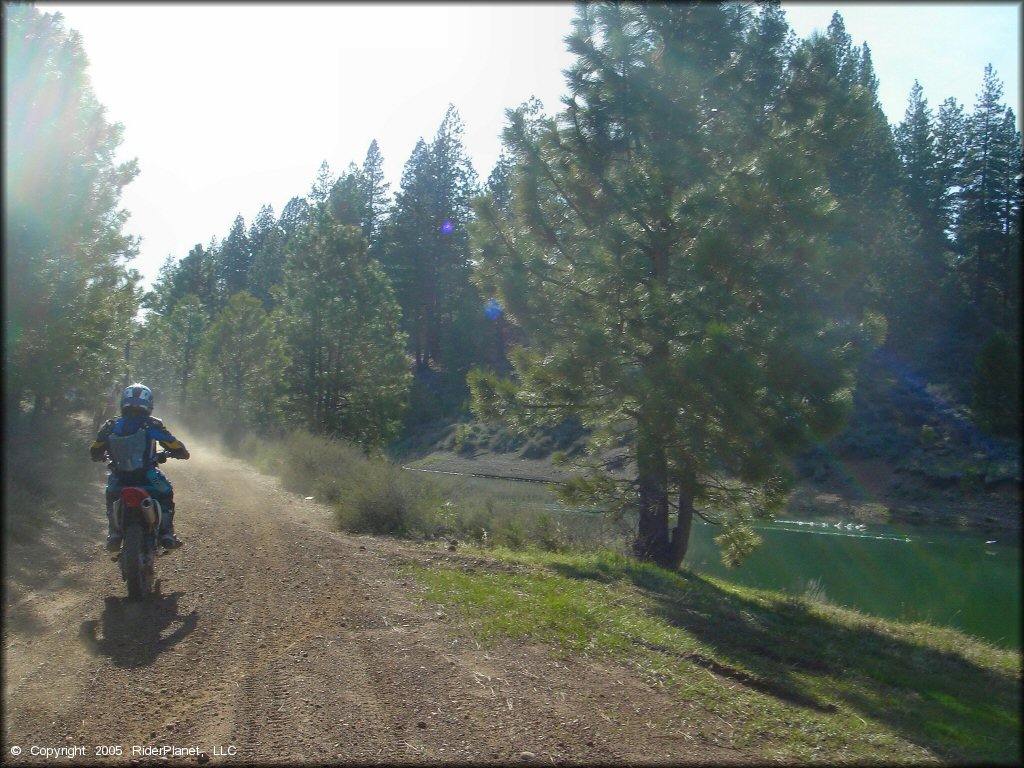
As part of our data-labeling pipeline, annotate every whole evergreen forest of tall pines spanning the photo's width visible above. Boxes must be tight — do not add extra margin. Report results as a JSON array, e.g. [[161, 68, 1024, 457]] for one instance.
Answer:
[[3, 2, 1022, 567]]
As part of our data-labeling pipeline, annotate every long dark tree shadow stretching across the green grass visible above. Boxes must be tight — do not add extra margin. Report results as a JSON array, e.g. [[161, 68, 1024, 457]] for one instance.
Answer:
[[551, 561, 1021, 763]]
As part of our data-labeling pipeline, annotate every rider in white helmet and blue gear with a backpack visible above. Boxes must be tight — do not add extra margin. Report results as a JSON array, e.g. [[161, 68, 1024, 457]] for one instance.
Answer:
[[89, 384, 188, 552]]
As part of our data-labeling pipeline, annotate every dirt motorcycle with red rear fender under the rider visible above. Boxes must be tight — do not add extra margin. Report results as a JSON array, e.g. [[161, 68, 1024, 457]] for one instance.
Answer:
[[113, 452, 176, 600]]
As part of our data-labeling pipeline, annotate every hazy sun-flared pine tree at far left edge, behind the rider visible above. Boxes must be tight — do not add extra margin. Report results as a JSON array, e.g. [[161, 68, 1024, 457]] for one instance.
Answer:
[[3, 4, 140, 416]]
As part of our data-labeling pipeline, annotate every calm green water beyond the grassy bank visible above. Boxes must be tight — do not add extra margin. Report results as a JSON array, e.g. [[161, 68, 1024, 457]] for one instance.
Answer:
[[685, 520, 1021, 648]]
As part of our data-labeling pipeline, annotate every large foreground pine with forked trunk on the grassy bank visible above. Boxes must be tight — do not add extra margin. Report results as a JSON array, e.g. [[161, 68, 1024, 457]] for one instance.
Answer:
[[470, 3, 876, 566]]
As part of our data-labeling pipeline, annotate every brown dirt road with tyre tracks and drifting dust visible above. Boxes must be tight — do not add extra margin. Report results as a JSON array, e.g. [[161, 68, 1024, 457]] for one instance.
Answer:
[[3, 435, 750, 765]]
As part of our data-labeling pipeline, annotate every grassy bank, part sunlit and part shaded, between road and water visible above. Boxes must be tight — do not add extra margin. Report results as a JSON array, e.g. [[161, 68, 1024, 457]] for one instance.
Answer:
[[415, 549, 1021, 764]]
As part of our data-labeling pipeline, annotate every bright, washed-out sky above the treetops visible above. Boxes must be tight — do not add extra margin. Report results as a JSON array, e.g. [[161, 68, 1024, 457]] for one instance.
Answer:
[[36, 2, 1021, 284]]
